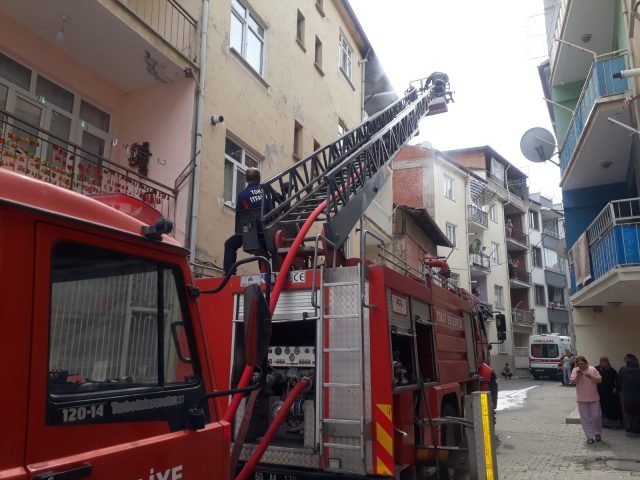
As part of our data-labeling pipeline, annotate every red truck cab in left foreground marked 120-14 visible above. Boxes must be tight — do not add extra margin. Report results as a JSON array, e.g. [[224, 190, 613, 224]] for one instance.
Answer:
[[0, 169, 240, 480]]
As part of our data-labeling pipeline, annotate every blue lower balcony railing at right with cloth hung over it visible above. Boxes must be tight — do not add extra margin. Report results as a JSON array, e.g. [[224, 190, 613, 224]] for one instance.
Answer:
[[587, 198, 640, 280]]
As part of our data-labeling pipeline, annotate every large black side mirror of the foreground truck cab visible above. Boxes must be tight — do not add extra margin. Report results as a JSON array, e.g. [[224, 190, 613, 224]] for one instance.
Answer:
[[244, 284, 271, 367]]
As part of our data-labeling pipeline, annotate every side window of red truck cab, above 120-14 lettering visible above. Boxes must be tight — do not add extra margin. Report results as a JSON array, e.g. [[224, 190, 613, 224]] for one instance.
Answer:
[[49, 242, 197, 394]]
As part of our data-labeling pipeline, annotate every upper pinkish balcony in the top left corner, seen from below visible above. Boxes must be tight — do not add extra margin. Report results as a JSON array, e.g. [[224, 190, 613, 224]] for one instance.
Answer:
[[0, 0, 195, 92]]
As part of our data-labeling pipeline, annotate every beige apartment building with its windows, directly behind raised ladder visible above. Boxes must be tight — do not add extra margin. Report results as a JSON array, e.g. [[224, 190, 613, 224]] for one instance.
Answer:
[[191, 0, 394, 267]]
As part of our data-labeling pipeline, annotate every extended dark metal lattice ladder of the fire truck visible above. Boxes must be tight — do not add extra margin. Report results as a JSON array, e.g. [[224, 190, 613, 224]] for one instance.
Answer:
[[262, 72, 453, 254]]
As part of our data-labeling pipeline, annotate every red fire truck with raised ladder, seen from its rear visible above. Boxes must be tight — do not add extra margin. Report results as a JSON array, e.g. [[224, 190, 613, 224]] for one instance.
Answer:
[[198, 73, 500, 479]]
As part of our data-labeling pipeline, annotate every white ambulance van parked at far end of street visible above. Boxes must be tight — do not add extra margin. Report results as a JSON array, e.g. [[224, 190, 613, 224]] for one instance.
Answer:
[[529, 333, 573, 380]]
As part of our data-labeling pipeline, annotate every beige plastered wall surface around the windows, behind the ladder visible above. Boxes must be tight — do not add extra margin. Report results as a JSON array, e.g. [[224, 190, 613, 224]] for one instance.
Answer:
[[196, 0, 362, 265]]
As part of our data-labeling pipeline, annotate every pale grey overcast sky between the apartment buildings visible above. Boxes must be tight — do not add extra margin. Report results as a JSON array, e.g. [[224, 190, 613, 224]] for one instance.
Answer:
[[350, 0, 561, 201]]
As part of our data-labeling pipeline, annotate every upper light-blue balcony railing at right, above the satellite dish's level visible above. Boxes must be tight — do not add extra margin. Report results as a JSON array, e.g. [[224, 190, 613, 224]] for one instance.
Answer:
[[560, 55, 629, 175]]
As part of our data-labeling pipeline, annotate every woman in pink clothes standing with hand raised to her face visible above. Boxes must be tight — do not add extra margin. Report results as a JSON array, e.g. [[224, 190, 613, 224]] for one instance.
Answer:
[[571, 355, 602, 444]]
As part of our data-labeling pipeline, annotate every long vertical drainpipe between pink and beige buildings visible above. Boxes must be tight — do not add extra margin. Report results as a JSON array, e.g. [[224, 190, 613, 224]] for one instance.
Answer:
[[189, 0, 209, 263]]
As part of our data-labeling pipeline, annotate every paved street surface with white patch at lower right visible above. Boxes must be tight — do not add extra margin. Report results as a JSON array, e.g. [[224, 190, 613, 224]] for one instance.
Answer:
[[496, 379, 640, 480]]
